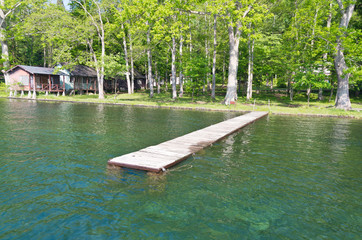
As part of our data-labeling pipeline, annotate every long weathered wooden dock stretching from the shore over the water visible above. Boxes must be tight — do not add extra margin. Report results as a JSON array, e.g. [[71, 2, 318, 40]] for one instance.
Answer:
[[108, 112, 268, 172]]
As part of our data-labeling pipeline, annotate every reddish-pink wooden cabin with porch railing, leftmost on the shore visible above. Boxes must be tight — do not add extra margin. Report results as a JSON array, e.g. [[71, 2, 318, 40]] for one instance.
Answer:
[[6, 65, 65, 92]]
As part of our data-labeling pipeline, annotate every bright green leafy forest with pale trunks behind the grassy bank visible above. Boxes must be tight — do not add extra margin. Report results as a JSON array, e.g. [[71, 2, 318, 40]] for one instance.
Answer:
[[0, 0, 362, 109]]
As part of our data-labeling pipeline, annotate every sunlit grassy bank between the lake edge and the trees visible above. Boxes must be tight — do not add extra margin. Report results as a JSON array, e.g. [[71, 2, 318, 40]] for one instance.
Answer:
[[0, 88, 362, 119]]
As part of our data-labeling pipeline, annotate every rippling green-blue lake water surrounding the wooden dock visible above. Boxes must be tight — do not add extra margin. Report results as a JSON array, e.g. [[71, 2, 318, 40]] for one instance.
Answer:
[[0, 99, 362, 239]]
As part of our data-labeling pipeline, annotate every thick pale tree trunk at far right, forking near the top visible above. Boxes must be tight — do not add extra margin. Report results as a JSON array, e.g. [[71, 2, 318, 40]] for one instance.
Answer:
[[334, 0, 355, 110]]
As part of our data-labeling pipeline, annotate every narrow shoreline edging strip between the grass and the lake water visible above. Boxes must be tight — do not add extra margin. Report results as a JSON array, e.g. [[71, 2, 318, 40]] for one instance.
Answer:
[[0, 97, 362, 119]]
